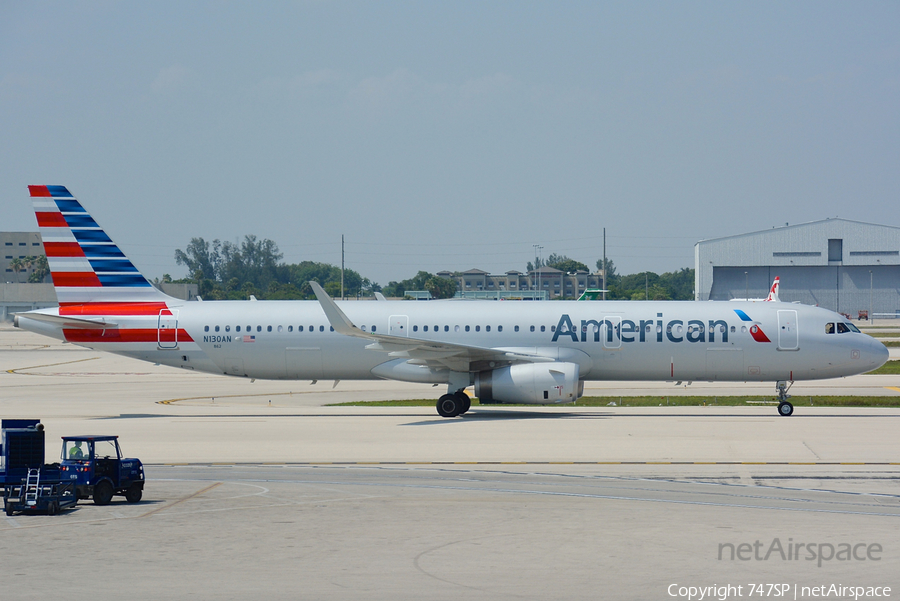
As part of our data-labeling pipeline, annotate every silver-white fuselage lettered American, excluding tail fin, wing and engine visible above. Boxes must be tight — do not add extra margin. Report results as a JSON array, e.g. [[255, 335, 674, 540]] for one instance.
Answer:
[[17, 301, 887, 382]]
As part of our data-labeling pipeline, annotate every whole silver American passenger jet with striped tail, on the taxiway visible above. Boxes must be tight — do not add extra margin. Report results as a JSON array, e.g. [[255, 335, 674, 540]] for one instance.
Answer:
[[14, 186, 888, 418]]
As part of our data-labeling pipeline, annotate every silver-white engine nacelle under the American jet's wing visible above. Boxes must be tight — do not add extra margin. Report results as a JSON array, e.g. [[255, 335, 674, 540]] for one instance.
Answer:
[[475, 363, 584, 405]]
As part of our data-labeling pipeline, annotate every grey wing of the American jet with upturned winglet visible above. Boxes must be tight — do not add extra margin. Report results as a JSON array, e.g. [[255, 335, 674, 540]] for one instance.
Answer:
[[309, 282, 554, 372]]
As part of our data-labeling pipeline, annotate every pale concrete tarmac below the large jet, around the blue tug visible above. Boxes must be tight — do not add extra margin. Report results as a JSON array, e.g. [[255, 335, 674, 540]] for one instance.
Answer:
[[0, 328, 900, 599]]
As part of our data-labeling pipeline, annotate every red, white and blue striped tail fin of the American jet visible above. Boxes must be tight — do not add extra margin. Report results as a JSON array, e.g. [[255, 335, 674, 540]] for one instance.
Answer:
[[28, 186, 175, 306]]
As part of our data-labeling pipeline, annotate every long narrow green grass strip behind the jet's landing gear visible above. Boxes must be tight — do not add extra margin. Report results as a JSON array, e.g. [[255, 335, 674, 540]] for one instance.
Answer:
[[327, 394, 900, 407]]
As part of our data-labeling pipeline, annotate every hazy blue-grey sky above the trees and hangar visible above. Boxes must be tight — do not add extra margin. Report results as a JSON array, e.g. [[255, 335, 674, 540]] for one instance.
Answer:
[[0, 0, 900, 285]]
